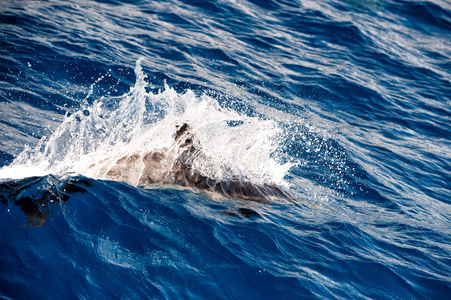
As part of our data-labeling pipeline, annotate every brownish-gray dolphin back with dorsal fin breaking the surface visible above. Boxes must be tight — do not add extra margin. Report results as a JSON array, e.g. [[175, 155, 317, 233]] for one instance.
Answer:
[[105, 123, 292, 202]]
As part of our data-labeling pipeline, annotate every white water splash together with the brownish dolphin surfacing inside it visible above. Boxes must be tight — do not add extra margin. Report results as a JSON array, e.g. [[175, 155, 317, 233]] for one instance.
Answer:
[[0, 61, 291, 201]]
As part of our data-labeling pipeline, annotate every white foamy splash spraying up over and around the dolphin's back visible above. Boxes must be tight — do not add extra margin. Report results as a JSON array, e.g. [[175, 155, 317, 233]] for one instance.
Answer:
[[0, 60, 291, 185]]
